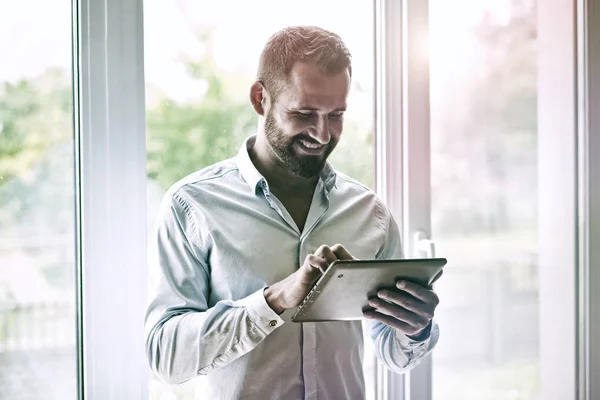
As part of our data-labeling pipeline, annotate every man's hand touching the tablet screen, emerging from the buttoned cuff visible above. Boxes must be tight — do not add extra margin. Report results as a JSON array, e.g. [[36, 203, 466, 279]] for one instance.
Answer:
[[264, 244, 354, 314]]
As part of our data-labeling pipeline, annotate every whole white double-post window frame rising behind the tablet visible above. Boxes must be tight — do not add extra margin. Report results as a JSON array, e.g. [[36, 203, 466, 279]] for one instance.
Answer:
[[375, 0, 431, 400]]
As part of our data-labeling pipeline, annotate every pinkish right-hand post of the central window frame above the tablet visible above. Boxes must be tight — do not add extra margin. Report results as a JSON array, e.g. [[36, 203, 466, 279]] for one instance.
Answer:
[[402, 0, 435, 400]]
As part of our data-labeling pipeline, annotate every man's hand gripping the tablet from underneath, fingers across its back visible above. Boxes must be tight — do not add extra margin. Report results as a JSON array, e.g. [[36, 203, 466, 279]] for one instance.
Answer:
[[363, 280, 440, 338]]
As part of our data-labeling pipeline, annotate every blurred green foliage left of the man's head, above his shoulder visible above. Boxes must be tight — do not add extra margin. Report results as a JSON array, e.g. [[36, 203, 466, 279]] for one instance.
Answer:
[[146, 29, 256, 189]]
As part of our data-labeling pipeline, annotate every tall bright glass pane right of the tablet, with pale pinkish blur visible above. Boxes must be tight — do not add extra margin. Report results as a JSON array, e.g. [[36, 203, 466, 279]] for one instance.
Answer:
[[430, 0, 539, 400]]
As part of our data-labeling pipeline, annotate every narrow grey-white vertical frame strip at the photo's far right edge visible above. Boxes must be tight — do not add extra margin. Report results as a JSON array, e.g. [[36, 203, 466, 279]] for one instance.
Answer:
[[576, 0, 600, 400]]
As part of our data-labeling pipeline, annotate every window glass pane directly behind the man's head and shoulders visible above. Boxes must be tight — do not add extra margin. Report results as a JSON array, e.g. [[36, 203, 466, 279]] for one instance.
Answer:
[[144, 0, 375, 399]]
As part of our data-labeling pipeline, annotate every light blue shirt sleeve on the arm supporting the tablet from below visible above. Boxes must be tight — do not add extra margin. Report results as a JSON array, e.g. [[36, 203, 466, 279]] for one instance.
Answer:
[[367, 208, 440, 373]]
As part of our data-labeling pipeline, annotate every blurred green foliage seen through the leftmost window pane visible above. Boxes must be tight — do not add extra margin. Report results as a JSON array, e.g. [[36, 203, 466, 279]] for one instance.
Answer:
[[0, 69, 74, 231]]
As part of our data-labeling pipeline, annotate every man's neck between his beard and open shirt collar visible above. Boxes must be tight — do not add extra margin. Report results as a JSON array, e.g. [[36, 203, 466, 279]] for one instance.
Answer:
[[248, 134, 319, 195]]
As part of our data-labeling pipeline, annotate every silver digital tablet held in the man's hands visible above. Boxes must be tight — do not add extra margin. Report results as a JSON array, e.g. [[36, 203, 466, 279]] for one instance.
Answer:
[[290, 258, 447, 322]]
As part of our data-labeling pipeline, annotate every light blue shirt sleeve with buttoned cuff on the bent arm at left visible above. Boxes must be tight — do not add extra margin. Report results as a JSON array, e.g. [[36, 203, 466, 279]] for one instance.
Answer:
[[144, 192, 284, 383]]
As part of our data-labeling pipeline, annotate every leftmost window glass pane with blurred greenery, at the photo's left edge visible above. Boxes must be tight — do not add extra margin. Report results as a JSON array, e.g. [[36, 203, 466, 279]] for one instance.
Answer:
[[0, 0, 77, 400]]
